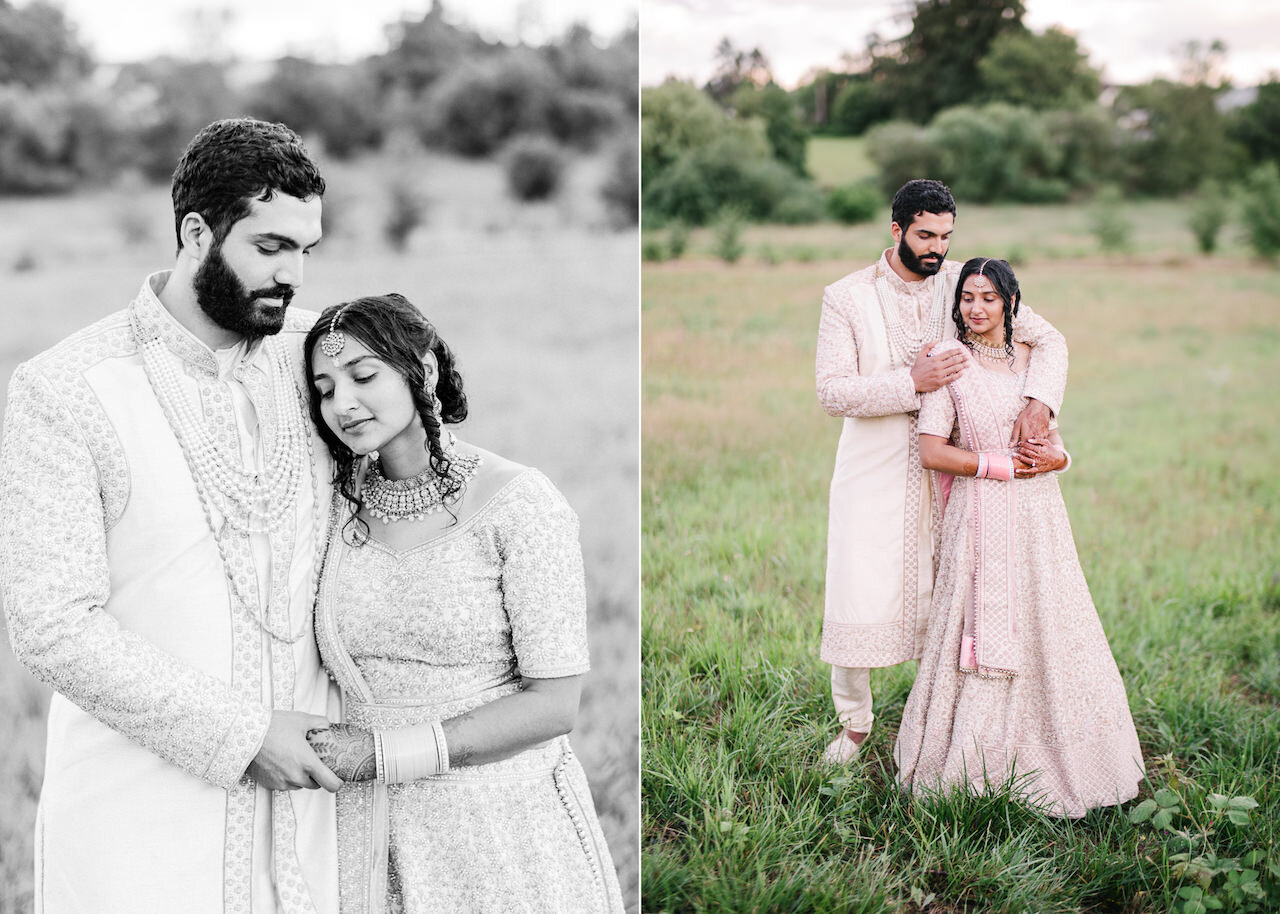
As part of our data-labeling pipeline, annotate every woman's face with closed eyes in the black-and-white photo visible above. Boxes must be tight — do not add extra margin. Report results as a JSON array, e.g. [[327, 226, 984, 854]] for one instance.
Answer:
[[311, 333, 425, 456]]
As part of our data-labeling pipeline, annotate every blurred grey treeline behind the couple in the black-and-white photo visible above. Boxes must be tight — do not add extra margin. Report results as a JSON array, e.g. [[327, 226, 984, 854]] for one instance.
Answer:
[[0, 0, 639, 193]]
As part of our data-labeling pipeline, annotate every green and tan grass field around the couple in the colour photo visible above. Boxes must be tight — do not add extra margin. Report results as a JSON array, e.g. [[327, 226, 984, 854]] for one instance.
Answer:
[[641, 204, 1280, 914]]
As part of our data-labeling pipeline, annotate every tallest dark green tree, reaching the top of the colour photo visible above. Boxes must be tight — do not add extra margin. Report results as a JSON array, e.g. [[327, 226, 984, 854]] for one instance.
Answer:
[[872, 0, 1027, 123]]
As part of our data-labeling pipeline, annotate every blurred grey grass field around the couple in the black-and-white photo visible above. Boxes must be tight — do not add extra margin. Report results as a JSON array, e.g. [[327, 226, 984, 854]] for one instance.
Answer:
[[0, 145, 639, 914]]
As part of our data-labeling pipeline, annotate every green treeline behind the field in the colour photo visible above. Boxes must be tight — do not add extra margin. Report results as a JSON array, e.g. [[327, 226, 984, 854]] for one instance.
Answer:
[[640, 0, 1280, 224]]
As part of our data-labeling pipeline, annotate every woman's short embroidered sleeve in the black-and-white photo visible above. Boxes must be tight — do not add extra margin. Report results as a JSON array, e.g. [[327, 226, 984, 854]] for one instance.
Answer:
[[499, 470, 590, 678]]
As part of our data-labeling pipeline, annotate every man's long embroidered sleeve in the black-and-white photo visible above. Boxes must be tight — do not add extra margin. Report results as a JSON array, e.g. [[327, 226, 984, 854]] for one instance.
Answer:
[[0, 366, 270, 787]]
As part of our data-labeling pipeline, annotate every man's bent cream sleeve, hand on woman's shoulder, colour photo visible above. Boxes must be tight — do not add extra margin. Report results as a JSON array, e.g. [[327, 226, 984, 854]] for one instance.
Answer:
[[815, 287, 920, 419]]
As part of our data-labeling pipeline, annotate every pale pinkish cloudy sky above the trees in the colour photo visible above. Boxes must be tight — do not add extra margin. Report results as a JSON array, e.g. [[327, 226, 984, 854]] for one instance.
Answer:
[[640, 0, 1280, 88]]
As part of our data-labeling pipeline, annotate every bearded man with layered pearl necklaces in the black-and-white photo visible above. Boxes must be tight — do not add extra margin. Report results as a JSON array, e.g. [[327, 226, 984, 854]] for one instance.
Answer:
[[0, 119, 342, 914]]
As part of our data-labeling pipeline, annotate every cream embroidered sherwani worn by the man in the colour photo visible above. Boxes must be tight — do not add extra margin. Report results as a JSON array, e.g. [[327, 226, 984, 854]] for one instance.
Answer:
[[817, 251, 1066, 668]]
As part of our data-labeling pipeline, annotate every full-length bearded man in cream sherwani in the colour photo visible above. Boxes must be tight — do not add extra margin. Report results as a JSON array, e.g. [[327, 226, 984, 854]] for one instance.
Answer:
[[817, 179, 1066, 763]]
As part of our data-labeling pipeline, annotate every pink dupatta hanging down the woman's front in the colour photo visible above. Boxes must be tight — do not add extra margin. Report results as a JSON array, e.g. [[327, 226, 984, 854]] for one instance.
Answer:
[[946, 349, 1018, 678]]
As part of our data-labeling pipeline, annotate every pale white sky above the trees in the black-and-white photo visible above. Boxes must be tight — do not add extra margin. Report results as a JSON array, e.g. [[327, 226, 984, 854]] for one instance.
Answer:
[[37, 0, 639, 63]]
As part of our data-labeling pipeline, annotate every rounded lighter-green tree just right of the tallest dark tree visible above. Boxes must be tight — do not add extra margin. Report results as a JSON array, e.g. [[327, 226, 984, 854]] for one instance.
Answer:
[[978, 27, 1102, 110]]
